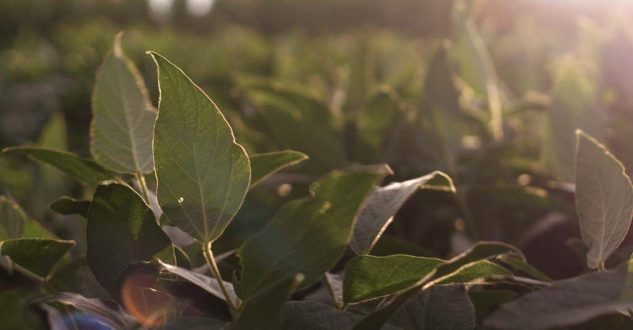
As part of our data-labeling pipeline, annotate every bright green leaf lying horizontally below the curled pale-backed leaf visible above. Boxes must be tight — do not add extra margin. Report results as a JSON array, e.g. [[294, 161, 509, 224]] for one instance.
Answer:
[[343, 254, 444, 304]]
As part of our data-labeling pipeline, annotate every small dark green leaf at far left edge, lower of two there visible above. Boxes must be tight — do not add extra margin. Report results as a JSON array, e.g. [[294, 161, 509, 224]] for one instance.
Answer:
[[0, 238, 75, 279]]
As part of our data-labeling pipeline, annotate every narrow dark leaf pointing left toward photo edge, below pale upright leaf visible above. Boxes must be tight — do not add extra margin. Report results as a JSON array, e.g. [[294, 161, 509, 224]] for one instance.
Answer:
[[2, 147, 114, 188]]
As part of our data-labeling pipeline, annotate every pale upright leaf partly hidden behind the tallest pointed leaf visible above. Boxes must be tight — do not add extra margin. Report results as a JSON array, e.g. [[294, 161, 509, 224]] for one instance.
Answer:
[[90, 33, 156, 174]]
